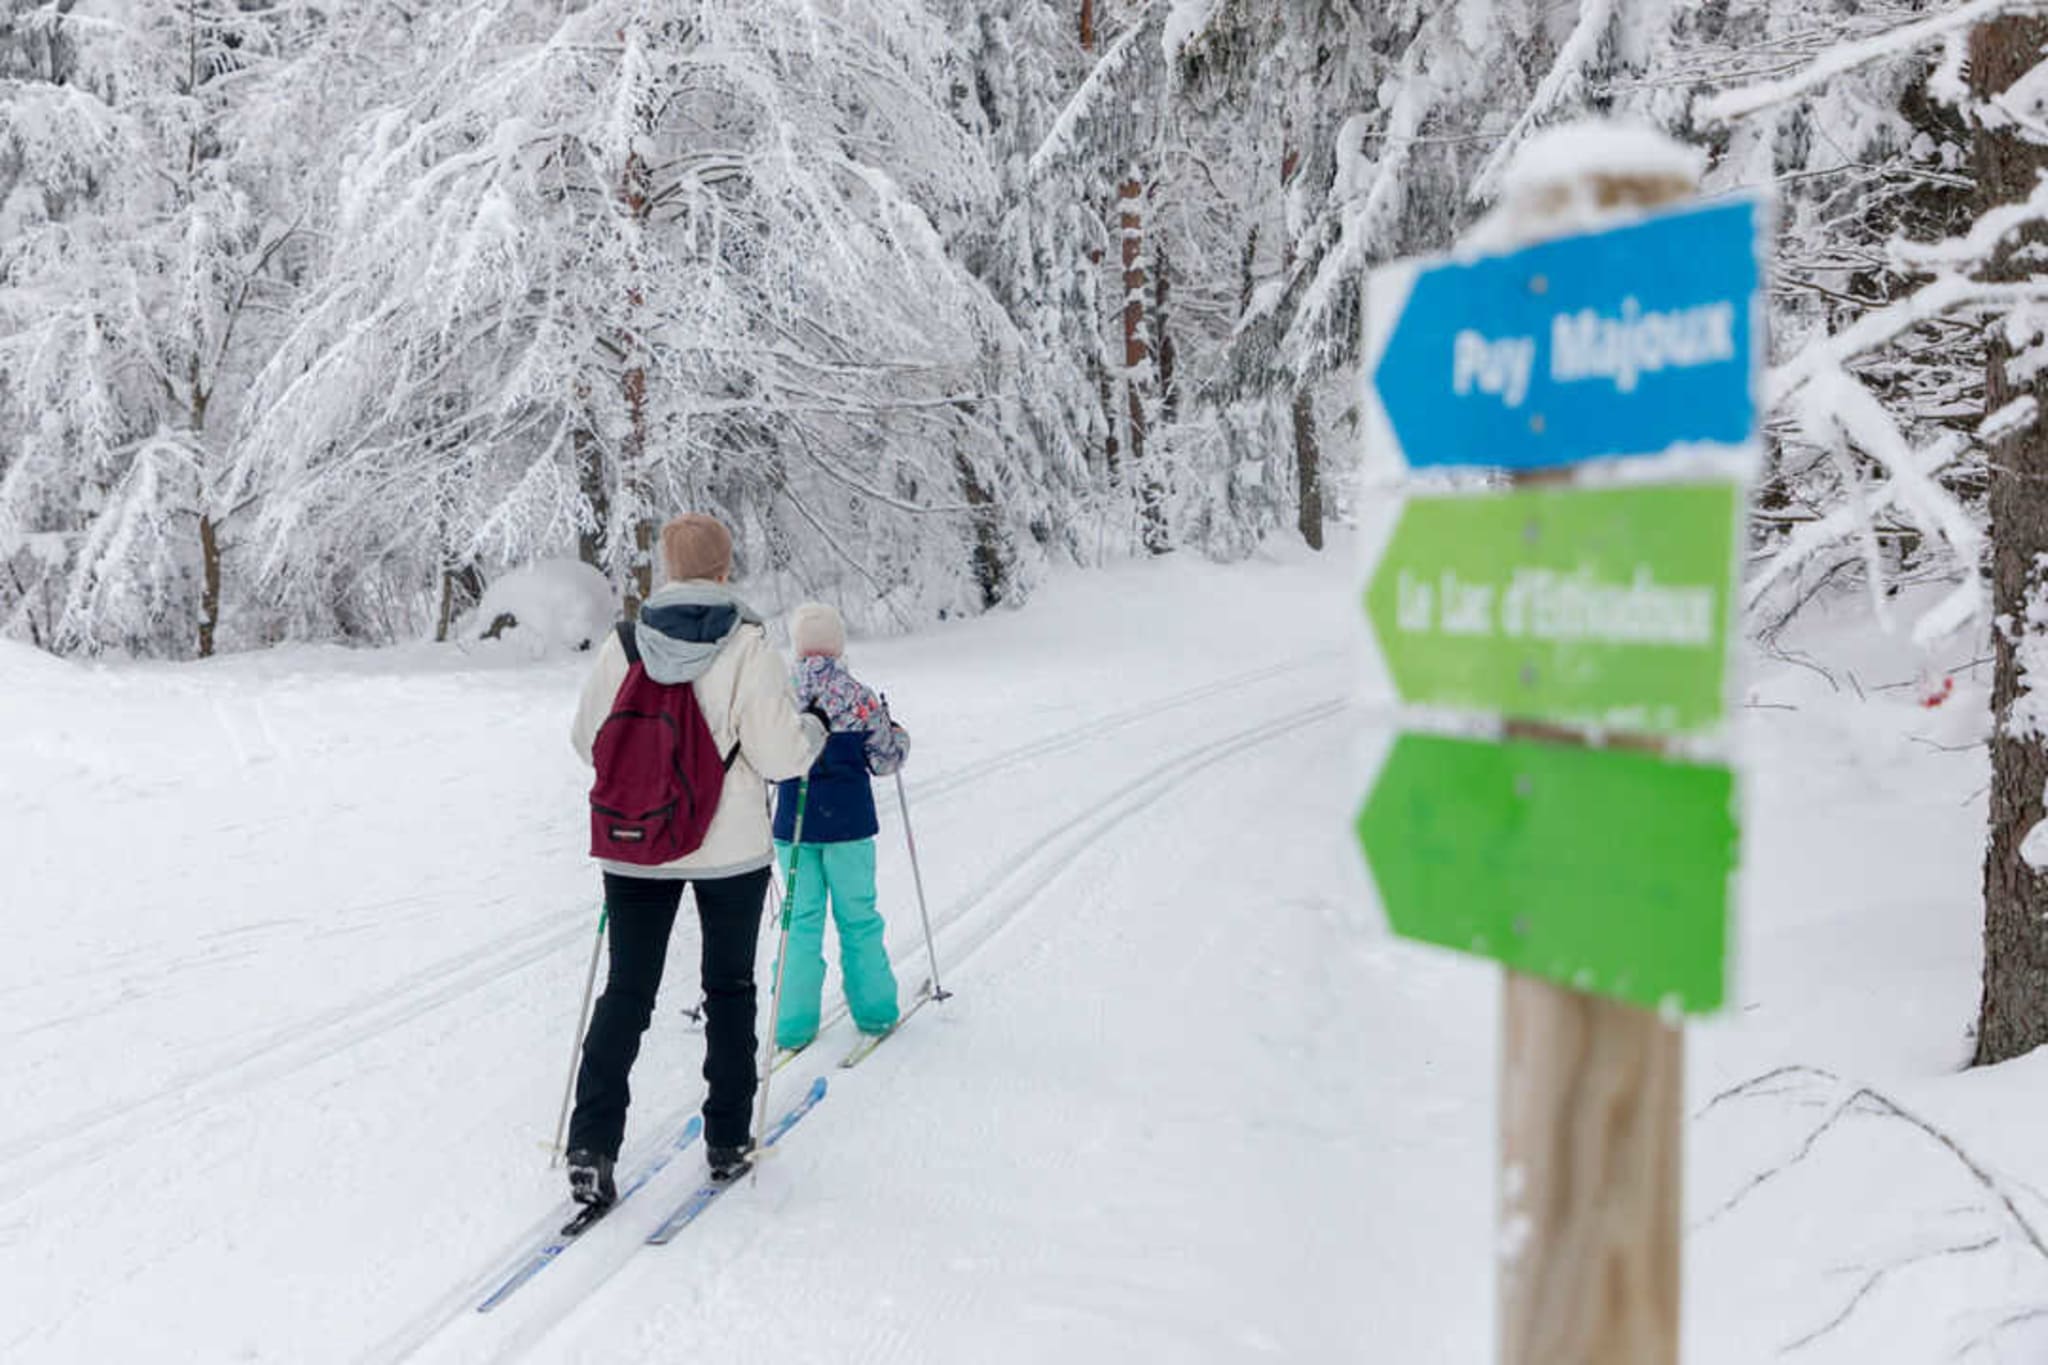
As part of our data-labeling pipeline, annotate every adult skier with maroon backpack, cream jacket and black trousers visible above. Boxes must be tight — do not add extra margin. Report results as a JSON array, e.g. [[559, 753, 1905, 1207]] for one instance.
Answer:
[[569, 514, 825, 1214]]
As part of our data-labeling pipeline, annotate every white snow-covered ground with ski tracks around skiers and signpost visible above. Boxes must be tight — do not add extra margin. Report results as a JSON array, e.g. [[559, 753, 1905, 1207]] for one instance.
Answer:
[[0, 551, 2048, 1365]]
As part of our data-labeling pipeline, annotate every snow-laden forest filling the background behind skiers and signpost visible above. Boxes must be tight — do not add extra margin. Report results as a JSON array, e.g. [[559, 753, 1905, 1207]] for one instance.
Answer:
[[0, 0, 2038, 657]]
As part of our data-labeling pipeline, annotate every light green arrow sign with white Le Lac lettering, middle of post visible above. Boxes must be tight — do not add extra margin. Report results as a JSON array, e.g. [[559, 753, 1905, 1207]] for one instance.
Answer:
[[1366, 483, 1743, 735]]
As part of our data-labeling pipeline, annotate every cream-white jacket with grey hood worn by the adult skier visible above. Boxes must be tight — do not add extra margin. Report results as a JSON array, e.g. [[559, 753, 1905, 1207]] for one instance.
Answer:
[[569, 581, 825, 878]]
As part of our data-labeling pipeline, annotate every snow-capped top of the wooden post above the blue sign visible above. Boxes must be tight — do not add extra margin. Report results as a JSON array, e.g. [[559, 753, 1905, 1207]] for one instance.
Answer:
[[1487, 119, 1706, 235]]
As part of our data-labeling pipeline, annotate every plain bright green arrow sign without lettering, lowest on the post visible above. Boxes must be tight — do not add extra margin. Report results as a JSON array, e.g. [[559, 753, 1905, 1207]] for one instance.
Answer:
[[1358, 735, 1737, 1013]]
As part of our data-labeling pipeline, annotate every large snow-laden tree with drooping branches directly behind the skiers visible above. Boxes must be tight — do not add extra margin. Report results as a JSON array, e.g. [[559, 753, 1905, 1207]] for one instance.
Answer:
[[240, 0, 1030, 628]]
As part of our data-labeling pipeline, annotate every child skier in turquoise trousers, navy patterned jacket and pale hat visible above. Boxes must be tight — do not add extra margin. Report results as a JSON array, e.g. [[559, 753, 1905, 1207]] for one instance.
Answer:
[[774, 602, 909, 1048]]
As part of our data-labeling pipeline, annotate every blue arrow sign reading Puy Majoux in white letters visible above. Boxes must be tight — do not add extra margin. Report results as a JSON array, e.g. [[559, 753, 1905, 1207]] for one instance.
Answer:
[[1368, 199, 1767, 471]]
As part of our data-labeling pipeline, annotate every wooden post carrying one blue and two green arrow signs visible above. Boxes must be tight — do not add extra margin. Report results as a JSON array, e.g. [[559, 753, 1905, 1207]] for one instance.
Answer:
[[1358, 141, 1767, 1365]]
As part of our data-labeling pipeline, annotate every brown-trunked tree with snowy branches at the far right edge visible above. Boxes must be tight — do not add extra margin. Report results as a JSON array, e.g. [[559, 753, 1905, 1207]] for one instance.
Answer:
[[1706, 0, 2048, 1062]]
